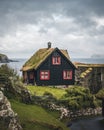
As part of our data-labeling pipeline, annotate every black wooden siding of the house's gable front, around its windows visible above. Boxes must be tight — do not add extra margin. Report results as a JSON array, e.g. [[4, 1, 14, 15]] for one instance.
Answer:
[[36, 51, 75, 85]]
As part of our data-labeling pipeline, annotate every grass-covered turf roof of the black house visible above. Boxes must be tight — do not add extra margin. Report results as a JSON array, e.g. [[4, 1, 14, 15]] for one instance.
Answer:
[[21, 48, 70, 71]]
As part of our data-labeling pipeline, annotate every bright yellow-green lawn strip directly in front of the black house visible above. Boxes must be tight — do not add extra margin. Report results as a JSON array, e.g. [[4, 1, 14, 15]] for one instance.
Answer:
[[26, 86, 66, 99]]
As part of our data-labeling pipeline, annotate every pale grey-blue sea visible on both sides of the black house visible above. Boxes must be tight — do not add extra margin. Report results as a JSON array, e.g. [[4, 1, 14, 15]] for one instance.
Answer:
[[0, 58, 104, 76]]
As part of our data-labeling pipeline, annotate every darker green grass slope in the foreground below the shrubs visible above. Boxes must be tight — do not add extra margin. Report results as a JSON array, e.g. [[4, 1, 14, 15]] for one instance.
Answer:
[[10, 100, 69, 130]]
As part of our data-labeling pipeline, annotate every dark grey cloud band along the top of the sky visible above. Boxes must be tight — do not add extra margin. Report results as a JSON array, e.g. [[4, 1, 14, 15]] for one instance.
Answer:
[[0, 0, 104, 30]]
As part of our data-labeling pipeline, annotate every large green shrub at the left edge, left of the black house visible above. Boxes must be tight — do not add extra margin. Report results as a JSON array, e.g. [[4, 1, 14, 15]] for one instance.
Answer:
[[0, 64, 24, 98]]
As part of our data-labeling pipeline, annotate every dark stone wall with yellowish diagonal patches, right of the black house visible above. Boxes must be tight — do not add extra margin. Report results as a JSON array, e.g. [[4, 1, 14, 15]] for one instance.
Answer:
[[75, 66, 104, 93]]
